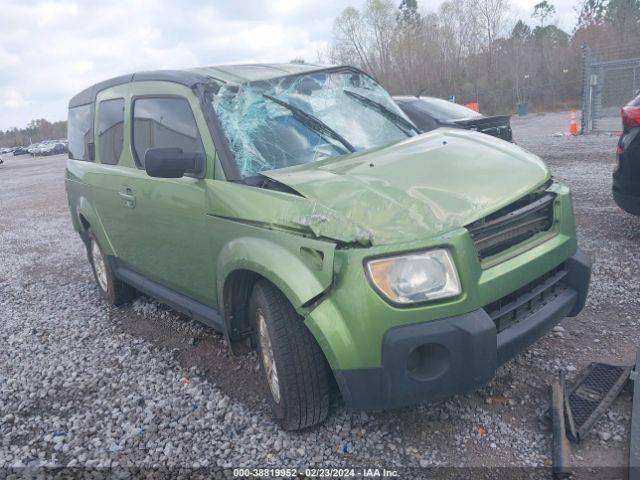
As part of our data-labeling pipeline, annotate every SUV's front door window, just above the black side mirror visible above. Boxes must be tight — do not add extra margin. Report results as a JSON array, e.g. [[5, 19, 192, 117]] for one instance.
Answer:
[[133, 97, 204, 167]]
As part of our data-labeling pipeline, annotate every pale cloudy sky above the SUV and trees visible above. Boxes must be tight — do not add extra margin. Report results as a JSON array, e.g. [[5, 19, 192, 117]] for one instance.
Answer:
[[0, 0, 575, 130]]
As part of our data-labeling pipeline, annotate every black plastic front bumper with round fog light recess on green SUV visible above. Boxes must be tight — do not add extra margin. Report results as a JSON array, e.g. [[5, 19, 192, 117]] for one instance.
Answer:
[[334, 251, 591, 410]]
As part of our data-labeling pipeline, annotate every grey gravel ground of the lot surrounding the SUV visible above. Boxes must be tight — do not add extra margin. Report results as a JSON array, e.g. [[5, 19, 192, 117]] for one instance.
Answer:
[[0, 114, 640, 478]]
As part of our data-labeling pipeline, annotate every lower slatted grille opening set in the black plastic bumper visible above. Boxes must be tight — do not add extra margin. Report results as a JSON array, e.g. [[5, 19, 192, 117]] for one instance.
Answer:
[[484, 264, 568, 332]]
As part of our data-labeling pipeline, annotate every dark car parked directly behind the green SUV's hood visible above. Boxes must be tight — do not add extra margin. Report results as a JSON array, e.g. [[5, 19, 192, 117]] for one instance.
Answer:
[[393, 97, 513, 142]]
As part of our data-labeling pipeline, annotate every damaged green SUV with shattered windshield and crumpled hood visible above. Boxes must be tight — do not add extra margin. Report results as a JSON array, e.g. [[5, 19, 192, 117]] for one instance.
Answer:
[[66, 64, 591, 429]]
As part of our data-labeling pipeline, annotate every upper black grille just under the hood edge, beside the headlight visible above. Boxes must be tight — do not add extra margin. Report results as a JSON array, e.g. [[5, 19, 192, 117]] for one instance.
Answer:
[[467, 192, 555, 259]]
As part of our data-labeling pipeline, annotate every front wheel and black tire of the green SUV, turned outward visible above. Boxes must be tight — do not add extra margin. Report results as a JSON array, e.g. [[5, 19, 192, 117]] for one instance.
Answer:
[[249, 280, 329, 430]]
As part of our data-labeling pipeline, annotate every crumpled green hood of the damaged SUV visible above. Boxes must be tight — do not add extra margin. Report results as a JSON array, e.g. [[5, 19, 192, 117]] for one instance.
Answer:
[[262, 129, 549, 245]]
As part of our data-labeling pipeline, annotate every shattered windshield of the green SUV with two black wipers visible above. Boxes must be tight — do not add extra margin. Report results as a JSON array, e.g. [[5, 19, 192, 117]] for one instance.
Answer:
[[213, 70, 417, 178]]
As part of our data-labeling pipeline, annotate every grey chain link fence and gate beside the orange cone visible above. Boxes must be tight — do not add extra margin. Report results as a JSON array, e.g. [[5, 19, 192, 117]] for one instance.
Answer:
[[582, 45, 640, 134]]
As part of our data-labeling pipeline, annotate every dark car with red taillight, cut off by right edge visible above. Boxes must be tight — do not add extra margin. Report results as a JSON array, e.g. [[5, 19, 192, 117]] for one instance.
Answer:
[[613, 95, 640, 215]]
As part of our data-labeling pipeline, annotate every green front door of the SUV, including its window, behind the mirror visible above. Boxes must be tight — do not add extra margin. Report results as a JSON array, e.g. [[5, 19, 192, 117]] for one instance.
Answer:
[[126, 88, 216, 304]]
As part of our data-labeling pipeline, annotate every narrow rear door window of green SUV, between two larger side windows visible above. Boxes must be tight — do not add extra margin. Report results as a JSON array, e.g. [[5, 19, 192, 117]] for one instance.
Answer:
[[98, 98, 124, 165]]
